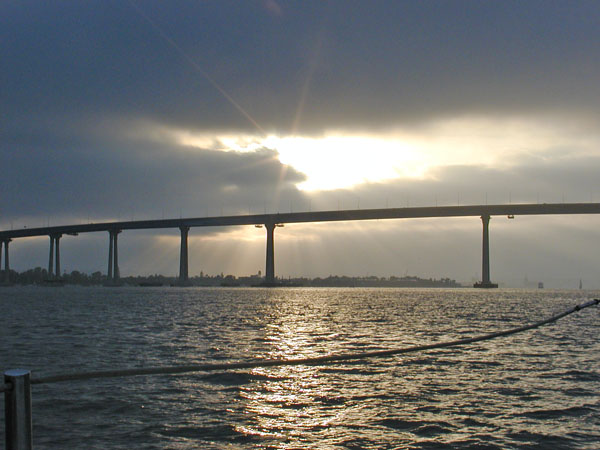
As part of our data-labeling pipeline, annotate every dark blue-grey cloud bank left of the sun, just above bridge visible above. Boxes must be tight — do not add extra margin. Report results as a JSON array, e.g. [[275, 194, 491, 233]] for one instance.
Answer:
[[0, 122, 304, 225]]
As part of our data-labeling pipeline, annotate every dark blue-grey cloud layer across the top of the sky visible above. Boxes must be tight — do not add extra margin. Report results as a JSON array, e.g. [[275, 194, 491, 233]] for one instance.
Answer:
[[0, 1, 600, 132]]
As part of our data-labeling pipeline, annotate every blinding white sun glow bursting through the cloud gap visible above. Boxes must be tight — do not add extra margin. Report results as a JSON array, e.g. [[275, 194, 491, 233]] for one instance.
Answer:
[[264, 135, 424, 191]]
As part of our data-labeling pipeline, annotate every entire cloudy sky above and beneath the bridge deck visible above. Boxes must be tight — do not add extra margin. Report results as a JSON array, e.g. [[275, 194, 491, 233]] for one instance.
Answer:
[[0, 0, 600, 288]]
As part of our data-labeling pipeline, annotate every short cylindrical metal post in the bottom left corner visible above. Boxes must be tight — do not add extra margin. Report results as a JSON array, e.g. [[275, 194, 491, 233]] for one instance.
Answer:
[[4, 369, 33, 450]]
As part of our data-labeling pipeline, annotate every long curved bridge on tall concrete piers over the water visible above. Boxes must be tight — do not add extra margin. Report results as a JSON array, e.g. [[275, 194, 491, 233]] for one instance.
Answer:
[[0, 203, 600, 288]]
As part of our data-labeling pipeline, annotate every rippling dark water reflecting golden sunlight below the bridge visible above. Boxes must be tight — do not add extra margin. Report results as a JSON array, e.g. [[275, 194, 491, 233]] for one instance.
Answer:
[[0, 287, 600, 449]]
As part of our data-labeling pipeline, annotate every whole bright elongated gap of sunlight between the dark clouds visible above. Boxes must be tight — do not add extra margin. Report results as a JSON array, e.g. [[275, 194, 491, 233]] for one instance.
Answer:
[[164, 113, 599, 192]]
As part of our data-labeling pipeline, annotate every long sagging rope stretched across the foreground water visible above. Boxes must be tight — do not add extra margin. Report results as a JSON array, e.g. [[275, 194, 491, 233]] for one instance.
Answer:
[[31, 299, 600, 384]]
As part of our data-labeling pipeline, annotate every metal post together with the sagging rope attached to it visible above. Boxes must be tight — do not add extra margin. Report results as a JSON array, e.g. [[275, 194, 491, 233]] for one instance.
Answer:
[[0, 299, 600, 450]]
